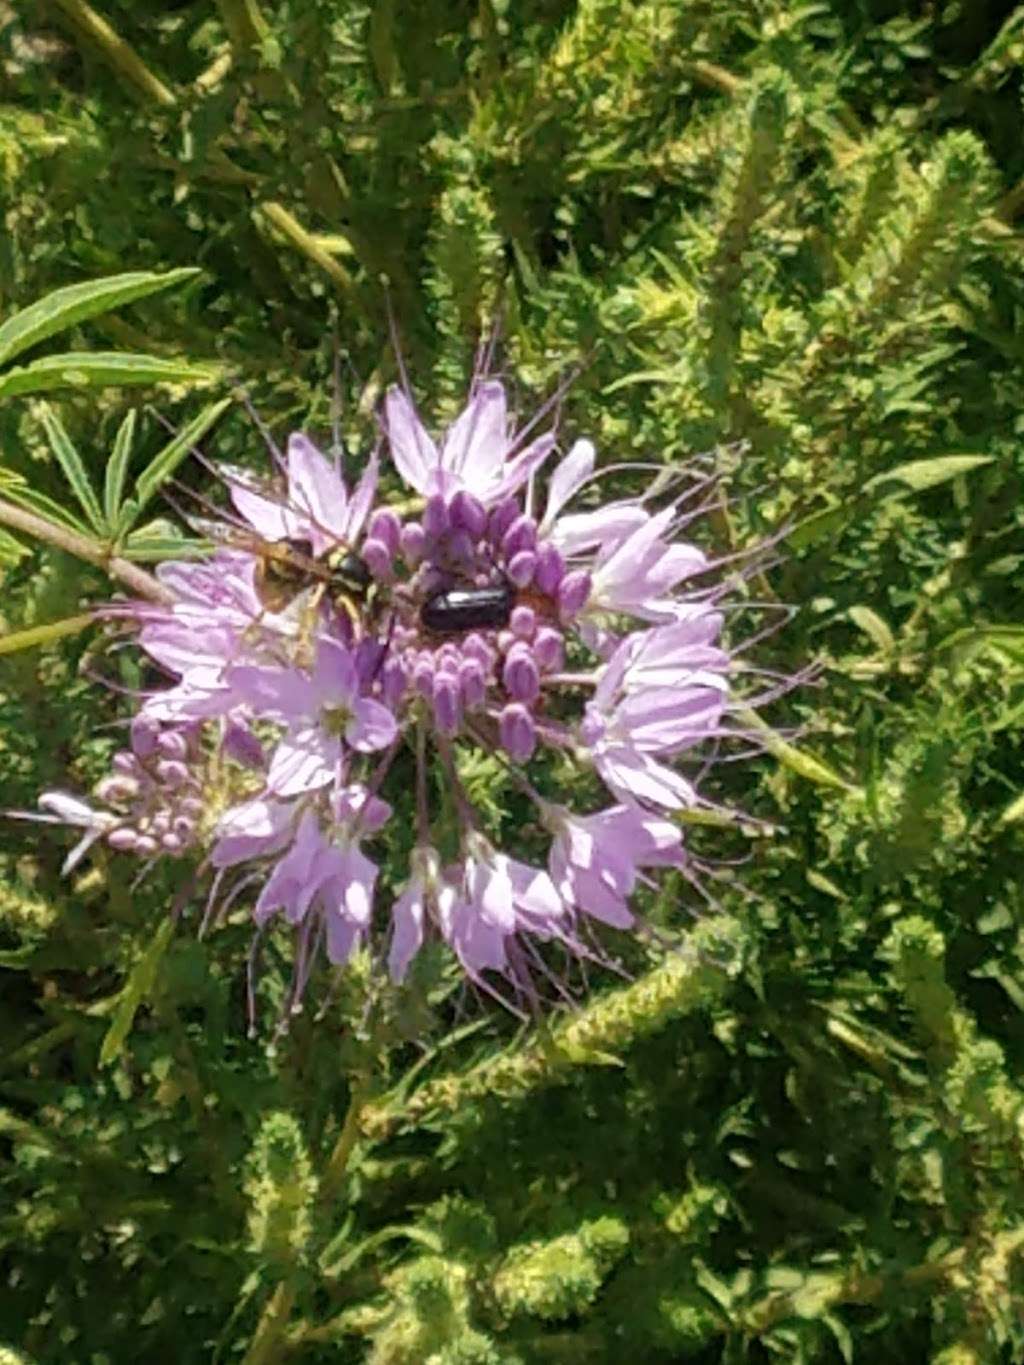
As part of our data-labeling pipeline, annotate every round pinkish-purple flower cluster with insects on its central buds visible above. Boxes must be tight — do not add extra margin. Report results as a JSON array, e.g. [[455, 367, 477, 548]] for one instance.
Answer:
[[36, 378, 770, 1015]]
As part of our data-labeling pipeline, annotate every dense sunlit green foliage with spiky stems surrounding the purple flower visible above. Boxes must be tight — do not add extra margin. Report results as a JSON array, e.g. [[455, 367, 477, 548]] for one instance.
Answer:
[[0, 0, 1024, 1365]]
